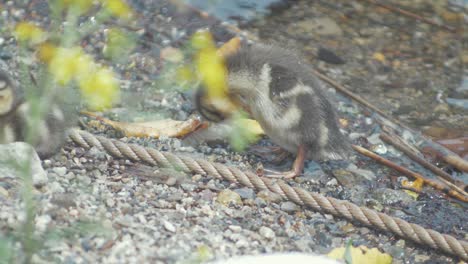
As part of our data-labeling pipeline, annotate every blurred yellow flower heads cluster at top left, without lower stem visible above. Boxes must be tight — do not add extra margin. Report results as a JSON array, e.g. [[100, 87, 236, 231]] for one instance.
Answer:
[[14, 0, 134, 110]]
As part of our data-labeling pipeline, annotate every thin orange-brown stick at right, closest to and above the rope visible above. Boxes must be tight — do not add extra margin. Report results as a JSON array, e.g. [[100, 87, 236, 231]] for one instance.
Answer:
[[352, 145, 468, 202]]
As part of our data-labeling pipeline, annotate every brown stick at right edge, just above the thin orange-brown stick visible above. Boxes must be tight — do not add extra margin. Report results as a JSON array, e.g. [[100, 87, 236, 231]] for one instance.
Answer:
[[380, 132, 468, 194]]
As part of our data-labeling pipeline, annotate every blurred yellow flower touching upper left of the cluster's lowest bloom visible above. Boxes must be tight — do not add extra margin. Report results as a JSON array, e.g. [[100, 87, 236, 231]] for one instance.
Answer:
[[49, 47, 95, 85]]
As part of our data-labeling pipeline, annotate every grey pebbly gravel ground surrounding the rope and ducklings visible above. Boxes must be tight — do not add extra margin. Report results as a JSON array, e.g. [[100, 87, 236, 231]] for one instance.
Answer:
[[0, 0, 468, 263]]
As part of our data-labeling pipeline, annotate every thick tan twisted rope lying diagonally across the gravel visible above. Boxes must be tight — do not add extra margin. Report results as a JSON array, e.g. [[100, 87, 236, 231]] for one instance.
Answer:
[[69, 129, 468, 260]]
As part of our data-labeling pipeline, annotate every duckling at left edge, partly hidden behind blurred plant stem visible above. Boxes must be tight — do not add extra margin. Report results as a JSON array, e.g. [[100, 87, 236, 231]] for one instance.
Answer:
[[0, 70, 72, 158]]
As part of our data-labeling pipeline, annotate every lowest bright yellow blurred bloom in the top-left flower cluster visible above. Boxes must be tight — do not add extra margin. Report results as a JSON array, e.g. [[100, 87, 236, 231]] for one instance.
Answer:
[[79, 68, 119, 111]]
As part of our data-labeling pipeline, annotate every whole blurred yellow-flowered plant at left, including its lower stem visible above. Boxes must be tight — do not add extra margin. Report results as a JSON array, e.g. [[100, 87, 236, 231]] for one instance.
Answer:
[[4, 0, 134, 263]]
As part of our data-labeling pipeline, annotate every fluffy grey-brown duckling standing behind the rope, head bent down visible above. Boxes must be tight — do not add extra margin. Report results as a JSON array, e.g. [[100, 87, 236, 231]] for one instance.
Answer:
[[195, 44, 351, 178]]
